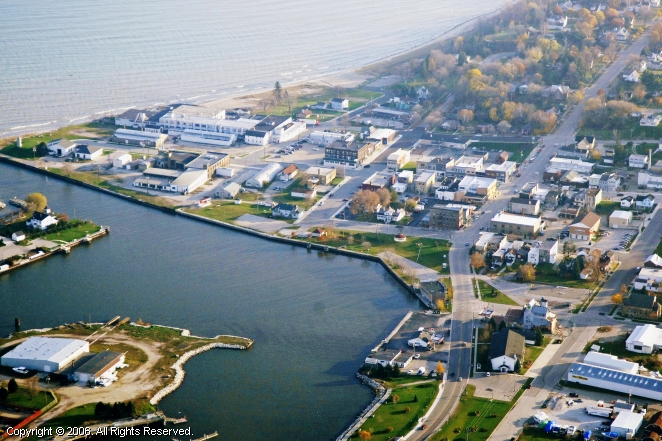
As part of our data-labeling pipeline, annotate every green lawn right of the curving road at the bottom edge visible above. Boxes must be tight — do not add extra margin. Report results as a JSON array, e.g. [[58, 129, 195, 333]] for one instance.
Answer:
[[430, 380, 530, 441]]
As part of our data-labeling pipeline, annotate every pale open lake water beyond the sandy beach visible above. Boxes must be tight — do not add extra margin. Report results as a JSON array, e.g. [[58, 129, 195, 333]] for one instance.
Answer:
[[0, 0, 505, 136]]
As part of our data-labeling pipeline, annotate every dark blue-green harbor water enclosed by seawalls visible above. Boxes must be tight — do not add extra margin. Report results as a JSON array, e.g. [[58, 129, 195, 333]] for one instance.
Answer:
[[0, 164, 419, 441]]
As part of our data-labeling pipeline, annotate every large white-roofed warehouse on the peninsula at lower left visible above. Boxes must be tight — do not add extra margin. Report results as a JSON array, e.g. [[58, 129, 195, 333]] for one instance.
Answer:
[[0, 337, 90, 372]]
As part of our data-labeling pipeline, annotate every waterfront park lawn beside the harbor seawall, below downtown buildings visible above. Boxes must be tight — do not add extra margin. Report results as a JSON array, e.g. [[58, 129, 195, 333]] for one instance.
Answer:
[[309, 231, 450, 274]]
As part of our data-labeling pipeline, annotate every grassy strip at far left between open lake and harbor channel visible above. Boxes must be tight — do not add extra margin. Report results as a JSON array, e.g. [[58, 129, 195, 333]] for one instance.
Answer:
[[0, 122, 117, 159]]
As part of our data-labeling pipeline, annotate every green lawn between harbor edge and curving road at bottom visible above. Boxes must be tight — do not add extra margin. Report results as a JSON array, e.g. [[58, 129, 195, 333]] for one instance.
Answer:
[[361, 381, 438, 441]]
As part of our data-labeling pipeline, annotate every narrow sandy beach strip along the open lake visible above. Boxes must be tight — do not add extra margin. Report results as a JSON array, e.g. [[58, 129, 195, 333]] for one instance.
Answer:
[[0, 0, 519, 140]]
